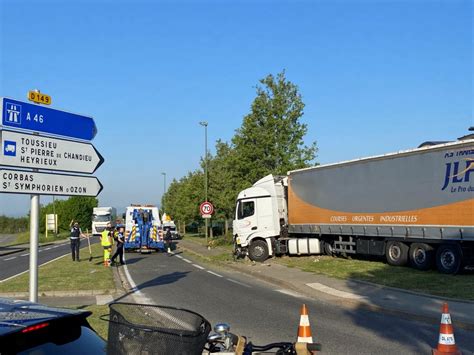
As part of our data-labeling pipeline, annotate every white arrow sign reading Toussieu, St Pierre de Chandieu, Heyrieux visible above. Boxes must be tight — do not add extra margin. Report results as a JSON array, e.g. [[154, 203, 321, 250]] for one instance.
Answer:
[[0, 131, 104, 174]]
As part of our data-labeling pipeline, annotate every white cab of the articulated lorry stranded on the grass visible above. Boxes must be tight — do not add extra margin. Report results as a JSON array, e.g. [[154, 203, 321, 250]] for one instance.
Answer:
[[233, 175, 288, 261]]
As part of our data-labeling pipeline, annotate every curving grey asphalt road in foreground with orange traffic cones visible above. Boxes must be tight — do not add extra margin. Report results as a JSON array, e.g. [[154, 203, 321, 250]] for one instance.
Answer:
[[126, 253, 474, 354]]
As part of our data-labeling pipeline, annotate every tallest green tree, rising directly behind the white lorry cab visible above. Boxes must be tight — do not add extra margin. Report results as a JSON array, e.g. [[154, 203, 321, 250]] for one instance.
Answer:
[[232, 71, 317, 190]]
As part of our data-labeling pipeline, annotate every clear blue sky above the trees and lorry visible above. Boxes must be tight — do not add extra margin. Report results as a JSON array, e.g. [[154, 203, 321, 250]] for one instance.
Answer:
[[0, 0, 474, 216]]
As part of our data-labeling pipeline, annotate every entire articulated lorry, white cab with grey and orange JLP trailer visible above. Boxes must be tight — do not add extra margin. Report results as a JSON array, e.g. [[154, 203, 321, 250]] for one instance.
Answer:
[[233, 135, 474, 273]]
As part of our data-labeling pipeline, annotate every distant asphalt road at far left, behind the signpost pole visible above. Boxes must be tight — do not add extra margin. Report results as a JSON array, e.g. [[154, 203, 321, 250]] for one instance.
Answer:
[[0, 237, 98, 282]]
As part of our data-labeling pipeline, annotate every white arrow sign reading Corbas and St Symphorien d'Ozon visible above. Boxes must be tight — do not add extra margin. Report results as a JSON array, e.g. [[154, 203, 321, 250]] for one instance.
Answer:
[[0, 169, 102, 196]]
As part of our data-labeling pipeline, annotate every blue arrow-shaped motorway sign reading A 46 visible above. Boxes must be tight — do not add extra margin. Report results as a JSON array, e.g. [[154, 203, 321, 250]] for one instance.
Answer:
[[0, 97, 97, 141]]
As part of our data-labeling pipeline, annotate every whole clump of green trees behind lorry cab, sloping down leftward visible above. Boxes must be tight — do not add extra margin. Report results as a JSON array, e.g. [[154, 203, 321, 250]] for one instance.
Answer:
[[162, 71, 317, 235]]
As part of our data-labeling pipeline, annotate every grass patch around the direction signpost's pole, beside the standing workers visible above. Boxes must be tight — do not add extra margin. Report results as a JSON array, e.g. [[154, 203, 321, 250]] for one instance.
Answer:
[[0, 241, 115, 294]]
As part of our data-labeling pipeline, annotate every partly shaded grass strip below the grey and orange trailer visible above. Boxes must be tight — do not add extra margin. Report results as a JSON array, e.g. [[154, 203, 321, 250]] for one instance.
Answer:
[[274, 256, 474, 301]]
